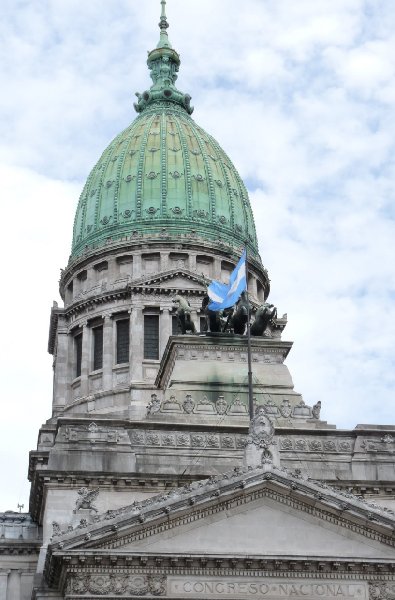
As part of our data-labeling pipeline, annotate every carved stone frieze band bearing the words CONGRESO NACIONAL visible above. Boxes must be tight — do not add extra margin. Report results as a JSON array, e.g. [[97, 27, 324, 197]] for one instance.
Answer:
[[60, 572, 395, 600]]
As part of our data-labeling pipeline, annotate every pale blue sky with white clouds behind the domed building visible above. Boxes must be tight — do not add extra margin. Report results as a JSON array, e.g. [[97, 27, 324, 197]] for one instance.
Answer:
[[0, 0, 395, 510]]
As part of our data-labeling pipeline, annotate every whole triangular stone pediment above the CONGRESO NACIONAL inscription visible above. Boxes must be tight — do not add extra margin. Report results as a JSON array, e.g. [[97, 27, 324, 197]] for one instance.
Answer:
[[50, 469, 395, 560]]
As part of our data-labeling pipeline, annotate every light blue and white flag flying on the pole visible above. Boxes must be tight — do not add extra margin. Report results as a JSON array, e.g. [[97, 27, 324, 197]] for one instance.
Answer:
[[207, 250, 247, 311]]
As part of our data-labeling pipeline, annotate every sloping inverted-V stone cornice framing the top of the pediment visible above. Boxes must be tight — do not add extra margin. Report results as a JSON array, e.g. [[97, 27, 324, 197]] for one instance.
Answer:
[[47, 464, 395, 550]]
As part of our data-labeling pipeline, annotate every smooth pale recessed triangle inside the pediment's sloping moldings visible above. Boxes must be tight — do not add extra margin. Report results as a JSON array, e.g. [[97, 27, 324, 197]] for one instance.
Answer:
[[120, 497, 394, 558]]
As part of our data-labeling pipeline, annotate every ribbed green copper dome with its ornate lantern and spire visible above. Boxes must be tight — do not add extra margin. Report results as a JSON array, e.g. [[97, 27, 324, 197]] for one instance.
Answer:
[[72, 0, 258, 257]]
